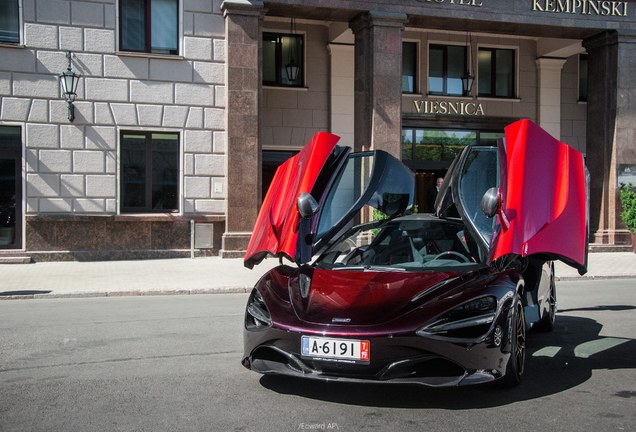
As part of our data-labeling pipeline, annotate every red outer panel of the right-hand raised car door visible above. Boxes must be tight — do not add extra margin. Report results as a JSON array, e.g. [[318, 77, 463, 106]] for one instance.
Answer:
[[492, 120, 587, 271]]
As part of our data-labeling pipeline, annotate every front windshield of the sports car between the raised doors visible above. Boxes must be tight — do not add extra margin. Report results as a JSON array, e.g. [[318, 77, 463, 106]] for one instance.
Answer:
[[314, 215, 482, 271]]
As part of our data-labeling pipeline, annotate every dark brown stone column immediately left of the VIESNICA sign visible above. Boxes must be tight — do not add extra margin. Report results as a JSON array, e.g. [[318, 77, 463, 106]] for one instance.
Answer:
[[350, 11, 407, 158]]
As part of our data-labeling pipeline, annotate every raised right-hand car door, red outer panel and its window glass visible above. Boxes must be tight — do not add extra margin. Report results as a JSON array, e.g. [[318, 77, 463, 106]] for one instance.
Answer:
[[435, 120, 589, 274]]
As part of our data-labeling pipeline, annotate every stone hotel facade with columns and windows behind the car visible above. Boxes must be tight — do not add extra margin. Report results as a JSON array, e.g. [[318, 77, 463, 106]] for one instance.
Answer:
[[0, 0, 636, 260]]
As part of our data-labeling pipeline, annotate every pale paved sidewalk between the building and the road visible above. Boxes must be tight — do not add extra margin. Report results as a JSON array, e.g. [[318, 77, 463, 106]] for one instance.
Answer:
[[0, 252, 636, 300]]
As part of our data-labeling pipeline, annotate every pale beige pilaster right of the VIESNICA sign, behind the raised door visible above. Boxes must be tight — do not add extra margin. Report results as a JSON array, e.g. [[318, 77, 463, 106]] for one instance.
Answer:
[[536, 57, 565, 139]]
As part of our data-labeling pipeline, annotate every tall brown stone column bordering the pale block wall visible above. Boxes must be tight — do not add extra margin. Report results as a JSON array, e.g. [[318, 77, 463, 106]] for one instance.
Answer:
[[219, 0, 264, 258]]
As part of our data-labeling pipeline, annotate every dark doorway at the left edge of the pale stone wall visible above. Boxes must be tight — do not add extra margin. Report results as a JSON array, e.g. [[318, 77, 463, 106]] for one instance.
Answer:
[[0, 126, 22, 249]]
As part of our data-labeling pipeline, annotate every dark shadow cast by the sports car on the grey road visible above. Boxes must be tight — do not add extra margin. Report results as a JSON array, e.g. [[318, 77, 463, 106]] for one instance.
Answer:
[[260, 306, 636, 410]]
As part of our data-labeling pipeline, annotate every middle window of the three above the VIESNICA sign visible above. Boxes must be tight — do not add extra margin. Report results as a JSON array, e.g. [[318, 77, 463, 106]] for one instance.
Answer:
[[428, 45, 466, 96]]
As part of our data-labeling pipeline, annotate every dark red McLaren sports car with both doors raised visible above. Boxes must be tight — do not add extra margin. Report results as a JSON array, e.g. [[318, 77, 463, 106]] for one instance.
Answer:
[[242, 120, 588, 386]]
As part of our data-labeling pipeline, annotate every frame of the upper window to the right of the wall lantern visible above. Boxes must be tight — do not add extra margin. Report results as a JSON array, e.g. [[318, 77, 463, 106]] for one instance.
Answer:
[[117, 0, 184, 57]]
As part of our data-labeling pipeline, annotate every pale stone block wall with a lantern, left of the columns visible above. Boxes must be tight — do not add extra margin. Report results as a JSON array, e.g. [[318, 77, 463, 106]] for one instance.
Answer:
[[0, 0, 228, 258]]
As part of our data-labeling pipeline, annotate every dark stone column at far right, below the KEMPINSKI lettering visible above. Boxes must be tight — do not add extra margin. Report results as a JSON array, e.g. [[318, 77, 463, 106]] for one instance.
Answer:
[[583, 32, 636, 245]]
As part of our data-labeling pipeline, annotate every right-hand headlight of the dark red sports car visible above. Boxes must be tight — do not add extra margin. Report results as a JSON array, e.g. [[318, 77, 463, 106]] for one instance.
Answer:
[[417, 296, 497, 339]]
